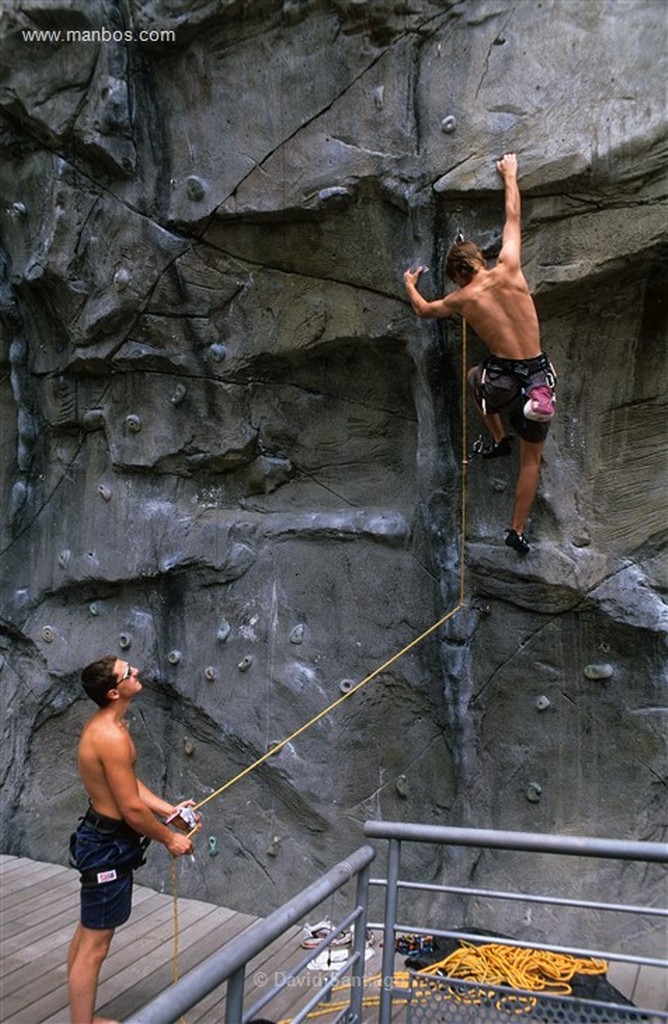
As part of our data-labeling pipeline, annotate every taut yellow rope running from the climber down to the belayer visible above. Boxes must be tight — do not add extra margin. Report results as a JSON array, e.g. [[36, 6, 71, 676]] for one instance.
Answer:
[[172, 319, 468, 981]]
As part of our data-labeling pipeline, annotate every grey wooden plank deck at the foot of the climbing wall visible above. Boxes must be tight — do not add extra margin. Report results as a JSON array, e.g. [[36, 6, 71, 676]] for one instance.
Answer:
[[0, 855, 668, 1024]]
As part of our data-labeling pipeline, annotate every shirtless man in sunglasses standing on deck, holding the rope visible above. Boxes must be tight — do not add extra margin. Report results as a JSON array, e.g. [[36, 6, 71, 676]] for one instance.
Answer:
[[68, 654, 198, 1024]]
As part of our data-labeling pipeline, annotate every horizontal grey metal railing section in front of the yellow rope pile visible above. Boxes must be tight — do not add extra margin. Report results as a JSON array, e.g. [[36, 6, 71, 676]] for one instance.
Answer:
[[365, 821, 668, 1024]]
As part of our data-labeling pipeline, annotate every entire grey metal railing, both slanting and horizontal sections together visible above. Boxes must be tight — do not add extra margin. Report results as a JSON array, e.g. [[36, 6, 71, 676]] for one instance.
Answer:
[[126, 821, 668, 1024]]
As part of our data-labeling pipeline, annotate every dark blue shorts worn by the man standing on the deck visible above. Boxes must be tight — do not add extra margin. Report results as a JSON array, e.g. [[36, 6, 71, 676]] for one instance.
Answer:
[[73, 822, 141, 929]]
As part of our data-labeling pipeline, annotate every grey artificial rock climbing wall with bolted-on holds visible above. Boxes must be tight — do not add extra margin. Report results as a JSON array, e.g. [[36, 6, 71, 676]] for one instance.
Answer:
[[0, 0, 666, 946]]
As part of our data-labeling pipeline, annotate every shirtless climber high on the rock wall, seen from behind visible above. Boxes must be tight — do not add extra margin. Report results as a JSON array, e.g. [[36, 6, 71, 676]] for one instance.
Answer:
[[404, 153, 555, 554]]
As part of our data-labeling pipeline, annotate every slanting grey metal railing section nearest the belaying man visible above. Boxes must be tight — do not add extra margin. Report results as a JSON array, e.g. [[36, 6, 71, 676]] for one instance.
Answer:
[[125, 846, 375, 1024]]
